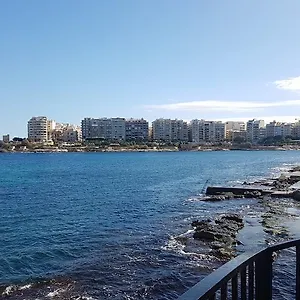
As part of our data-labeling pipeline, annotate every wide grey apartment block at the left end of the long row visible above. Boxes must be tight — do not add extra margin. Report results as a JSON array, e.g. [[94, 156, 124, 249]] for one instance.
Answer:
[[81, 118, 125, 141]]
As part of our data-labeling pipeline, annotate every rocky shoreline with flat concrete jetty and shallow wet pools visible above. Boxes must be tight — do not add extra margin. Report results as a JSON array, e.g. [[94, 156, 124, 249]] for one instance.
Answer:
[[175, 164, 300, 263]]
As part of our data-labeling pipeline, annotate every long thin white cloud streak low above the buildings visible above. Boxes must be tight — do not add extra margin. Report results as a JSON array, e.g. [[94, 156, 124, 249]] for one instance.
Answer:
[[145, 100, 300, 113]]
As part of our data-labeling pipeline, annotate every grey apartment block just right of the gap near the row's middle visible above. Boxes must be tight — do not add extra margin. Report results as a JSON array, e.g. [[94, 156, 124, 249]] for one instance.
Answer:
[[152, 119, 188, 142]]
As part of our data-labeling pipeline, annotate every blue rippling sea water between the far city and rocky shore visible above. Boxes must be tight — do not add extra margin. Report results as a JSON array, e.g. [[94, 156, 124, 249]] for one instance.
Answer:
[[0, 151, 300, 299]]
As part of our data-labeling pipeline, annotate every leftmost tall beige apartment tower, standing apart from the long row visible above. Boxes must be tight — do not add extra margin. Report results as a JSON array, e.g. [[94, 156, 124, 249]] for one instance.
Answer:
[[27, 116, 49, 142]]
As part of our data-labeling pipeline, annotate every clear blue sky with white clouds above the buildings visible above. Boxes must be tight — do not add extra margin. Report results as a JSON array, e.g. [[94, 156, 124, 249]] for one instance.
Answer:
[[0, 0, 300, 138]]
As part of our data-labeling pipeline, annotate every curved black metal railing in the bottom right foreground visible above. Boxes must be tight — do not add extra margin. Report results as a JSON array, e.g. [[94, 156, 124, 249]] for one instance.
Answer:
[[178, 240, 300, 300]]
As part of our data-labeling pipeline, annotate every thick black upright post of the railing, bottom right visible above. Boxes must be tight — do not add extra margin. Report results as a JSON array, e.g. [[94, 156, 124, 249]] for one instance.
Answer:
[[255, 249, 273, 300]]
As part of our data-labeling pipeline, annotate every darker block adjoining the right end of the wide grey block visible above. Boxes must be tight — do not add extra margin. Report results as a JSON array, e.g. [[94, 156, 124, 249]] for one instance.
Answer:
[[125, 119, 149, 141]]
